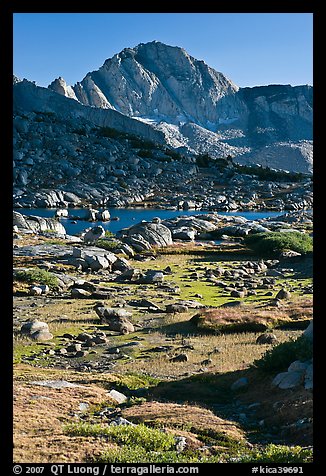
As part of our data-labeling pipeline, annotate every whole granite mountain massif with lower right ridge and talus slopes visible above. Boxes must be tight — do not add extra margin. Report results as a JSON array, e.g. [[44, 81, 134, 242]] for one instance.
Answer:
[[44, 41, 313, 173]]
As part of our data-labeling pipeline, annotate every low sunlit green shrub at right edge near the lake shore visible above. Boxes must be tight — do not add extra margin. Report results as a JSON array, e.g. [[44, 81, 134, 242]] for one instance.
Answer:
[[244, 231, 313, 255]]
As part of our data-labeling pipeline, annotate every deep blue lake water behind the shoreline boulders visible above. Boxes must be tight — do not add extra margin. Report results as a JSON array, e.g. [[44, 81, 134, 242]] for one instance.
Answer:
[[16, 208, 282, 235]]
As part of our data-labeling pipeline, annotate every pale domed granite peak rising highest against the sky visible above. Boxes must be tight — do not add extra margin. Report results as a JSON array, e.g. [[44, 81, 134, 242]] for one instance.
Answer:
[[70, 42, 239, 127]]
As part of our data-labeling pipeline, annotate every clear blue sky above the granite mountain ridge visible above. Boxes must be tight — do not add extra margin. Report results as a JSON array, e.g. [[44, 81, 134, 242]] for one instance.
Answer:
[[14, 13, 313, 87]]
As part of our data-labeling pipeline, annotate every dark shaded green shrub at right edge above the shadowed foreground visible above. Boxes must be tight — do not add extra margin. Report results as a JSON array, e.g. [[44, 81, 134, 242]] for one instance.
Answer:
[[253, 336, 313, 372]]
